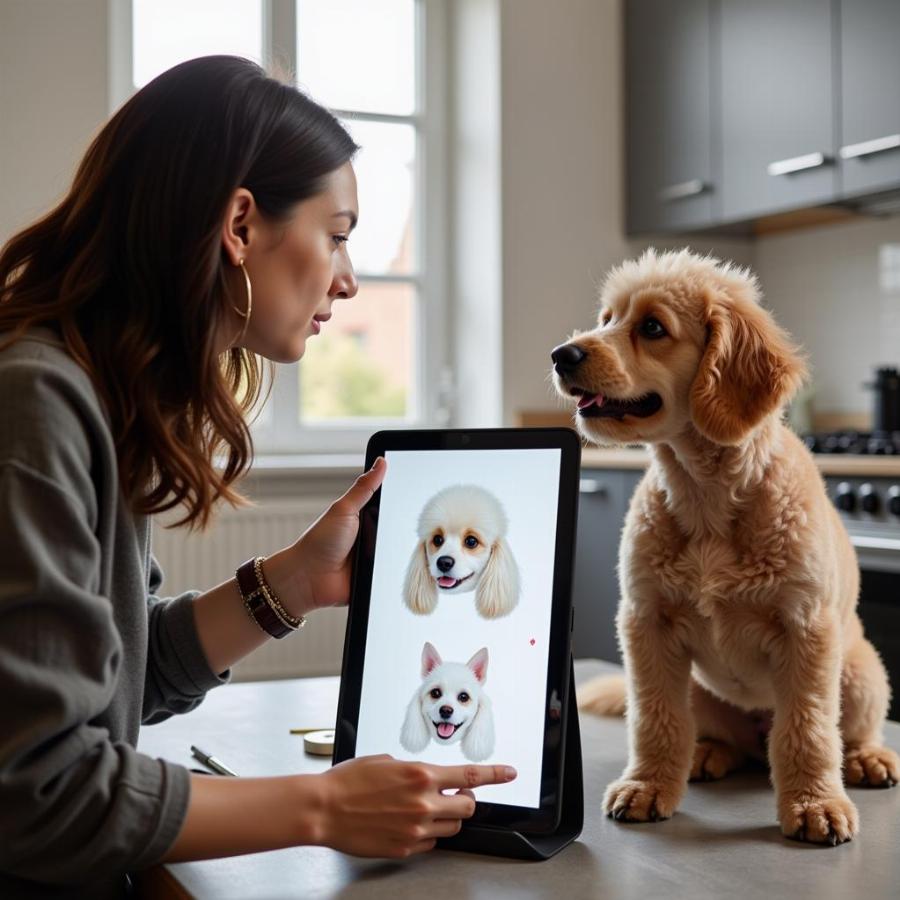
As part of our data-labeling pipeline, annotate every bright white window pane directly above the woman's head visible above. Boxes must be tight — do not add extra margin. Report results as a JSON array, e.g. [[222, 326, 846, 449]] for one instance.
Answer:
[[133, 0, 262, 88]]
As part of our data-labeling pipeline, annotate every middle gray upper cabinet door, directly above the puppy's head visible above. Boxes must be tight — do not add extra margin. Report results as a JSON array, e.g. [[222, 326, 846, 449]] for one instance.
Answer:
[[716, 0, 837, 222]]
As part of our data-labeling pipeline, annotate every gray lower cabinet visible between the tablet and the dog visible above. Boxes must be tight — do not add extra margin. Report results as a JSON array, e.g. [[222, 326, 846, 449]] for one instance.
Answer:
[[572, 469, 644, 662]]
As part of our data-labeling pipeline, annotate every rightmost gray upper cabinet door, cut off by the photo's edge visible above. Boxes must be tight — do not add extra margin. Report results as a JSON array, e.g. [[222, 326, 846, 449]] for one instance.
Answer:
[[840, 0, 900, 197]]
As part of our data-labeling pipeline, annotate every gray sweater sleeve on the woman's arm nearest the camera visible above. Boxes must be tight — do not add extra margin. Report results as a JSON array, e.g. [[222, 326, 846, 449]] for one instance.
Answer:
[[0, 460, 190, 884]]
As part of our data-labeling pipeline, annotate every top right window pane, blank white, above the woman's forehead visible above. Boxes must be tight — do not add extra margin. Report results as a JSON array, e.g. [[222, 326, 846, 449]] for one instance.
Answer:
[[297, 0, 416, 115]]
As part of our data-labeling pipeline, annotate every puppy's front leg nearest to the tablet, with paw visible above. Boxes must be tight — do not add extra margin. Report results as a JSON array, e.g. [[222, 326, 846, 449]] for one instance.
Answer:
[[603, 603, 695, 822]]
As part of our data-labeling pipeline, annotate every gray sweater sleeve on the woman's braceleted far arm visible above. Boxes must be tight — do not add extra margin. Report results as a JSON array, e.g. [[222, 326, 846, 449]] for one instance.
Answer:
[[142, 555, 231, 725]]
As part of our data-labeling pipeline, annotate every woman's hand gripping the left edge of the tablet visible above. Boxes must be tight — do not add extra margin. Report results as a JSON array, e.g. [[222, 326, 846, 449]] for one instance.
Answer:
[[263, 456, 387, 616]]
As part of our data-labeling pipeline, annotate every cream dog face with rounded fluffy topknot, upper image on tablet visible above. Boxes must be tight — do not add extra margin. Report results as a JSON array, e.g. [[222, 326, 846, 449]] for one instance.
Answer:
[[403, 484, 519, 619]]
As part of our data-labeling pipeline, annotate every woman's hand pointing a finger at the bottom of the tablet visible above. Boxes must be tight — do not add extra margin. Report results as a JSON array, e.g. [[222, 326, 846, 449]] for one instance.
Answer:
[[316, 755, 516, 858]]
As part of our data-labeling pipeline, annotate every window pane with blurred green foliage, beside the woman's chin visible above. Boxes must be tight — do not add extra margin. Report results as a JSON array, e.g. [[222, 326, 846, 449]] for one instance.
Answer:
[[298, 282, 415, 425]]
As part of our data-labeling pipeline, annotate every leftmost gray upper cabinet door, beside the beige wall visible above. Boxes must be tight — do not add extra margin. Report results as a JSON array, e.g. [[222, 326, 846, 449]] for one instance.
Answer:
[[625, 0, 716, 234]]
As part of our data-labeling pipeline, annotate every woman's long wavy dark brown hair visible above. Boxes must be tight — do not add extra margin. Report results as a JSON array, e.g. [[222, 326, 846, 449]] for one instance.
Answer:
[[0, 56, 357, 528]]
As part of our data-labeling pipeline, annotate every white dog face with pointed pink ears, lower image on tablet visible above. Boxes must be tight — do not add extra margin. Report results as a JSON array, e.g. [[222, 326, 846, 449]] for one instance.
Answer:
[[400, 642, 494, 762]]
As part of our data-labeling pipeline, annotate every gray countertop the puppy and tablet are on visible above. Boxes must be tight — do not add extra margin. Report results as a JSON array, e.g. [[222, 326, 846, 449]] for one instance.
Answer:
[[139, 660, 900, 900]]
